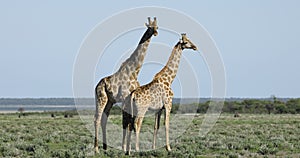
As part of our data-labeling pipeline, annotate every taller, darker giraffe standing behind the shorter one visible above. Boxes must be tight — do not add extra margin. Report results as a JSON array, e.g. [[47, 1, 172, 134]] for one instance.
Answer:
[[94, 17, 158, 153]]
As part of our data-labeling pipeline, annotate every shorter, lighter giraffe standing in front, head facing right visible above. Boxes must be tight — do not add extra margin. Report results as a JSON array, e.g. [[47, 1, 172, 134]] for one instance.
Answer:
[[123, 34, 197, 154]]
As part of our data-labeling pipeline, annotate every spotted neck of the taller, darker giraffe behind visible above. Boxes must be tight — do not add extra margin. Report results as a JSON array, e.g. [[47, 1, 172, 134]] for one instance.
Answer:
[[119, 27, 154, 79]]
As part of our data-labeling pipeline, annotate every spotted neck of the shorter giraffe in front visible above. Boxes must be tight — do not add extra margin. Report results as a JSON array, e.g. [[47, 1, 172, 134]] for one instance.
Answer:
[[154, 42, 182, 86]]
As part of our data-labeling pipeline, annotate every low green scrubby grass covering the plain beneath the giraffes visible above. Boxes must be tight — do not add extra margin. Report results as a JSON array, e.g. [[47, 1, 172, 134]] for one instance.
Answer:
[[0, 113, 300, 157]]
